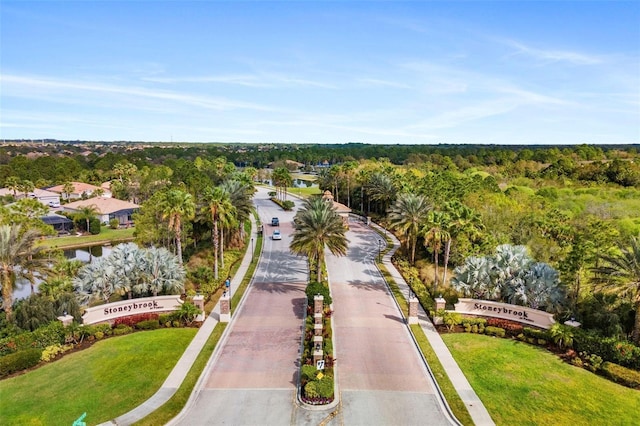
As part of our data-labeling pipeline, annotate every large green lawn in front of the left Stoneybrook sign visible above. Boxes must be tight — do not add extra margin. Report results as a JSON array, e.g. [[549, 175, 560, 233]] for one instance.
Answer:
[[0, 328, 197, 425]]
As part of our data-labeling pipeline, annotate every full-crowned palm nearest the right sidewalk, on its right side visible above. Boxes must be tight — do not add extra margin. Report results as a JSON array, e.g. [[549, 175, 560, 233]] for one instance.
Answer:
[[389, 192, 432, 265]]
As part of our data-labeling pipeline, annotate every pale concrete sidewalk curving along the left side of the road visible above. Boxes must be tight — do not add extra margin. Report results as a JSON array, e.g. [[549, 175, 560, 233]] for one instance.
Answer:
[[101, 215, 257, 426]]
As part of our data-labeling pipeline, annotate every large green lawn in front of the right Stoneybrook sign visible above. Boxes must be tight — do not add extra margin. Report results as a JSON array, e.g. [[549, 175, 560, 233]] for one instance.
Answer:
[[442, 333, 640, 426]]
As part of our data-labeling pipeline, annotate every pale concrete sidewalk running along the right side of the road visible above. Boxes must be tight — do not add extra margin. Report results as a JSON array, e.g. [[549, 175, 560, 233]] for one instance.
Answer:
[[371, 222, 495, 426]]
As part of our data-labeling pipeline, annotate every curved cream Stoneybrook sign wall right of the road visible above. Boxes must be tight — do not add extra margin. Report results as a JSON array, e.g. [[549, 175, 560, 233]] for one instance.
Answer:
[[455, 299, 555, 329]]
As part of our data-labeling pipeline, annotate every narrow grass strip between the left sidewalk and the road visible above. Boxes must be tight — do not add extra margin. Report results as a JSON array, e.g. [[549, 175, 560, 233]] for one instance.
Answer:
[[134, 323, 227, 426]]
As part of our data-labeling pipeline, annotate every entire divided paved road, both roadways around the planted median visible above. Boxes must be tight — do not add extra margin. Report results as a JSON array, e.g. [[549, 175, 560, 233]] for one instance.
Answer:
[[172, 189, 450, 425]]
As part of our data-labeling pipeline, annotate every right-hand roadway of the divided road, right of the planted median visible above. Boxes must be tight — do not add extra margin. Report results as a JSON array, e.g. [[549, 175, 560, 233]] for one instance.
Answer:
[[327, 221, 450, 426]]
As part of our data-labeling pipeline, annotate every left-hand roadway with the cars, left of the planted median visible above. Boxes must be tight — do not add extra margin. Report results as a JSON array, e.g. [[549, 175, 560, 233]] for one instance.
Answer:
[[177, 189, 336, 425]]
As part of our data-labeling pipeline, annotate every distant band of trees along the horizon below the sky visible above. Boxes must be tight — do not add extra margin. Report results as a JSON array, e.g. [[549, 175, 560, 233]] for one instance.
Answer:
[[0, 142, 640, 187]]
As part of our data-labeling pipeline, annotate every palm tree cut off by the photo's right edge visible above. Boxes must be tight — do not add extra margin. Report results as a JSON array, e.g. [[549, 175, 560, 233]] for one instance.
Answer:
[[593, 237, 640, 344]]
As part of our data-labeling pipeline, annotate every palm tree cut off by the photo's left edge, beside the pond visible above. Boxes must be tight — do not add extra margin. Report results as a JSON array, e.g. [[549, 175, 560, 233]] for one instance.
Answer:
[[0, 225, 48, 320]]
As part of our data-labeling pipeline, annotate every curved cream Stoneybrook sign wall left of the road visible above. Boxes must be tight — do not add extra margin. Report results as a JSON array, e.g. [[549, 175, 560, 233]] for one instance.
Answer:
[[82, 295, 182, 324]]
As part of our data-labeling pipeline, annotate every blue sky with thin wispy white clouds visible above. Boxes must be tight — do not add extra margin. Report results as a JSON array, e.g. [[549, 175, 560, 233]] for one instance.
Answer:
[[0, 0, 640, 144]]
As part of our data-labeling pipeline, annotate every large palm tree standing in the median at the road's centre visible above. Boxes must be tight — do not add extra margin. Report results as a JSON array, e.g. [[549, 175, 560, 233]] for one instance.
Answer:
[[289, 197, 349, 282]]
